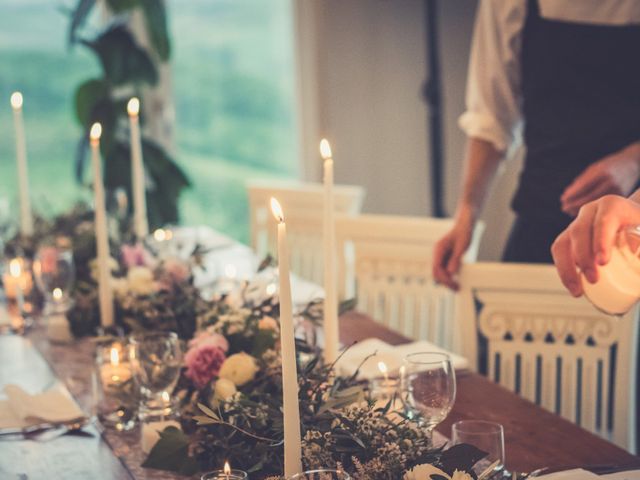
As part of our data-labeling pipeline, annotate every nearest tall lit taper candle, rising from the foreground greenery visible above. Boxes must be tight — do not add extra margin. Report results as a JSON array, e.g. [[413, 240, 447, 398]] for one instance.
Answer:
[[271, 198, 302, 477]]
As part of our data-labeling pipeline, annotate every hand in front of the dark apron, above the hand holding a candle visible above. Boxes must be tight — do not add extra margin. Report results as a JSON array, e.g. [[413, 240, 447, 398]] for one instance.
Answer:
[[560, 143, 640, 217]]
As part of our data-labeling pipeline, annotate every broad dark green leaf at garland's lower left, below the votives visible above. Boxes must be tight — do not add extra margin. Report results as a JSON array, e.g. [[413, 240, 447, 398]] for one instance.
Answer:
[[142, 427, 198, 475]]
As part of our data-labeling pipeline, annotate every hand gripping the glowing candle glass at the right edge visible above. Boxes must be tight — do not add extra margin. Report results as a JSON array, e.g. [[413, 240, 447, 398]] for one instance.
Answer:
[[551, 195, 640, 297]]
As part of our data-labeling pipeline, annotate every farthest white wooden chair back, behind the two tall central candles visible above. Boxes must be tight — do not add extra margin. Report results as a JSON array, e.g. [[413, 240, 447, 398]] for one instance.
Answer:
[[246, 180, 365, 285]]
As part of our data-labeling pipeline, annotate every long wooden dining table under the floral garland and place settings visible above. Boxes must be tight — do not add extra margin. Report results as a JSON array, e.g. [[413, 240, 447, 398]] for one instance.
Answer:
[[0, 312, 640, 480]]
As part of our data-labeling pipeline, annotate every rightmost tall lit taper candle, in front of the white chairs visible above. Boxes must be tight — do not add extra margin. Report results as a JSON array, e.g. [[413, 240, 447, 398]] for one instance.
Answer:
[[320, 139, 339, 364]]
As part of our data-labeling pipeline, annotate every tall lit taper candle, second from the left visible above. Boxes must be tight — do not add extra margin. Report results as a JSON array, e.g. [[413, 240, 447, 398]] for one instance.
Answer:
[[90, 123, 113, 327]]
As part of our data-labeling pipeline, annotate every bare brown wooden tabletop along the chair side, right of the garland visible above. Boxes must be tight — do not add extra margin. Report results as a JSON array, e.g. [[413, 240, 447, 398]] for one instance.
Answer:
[[340, 312, 640, 472]]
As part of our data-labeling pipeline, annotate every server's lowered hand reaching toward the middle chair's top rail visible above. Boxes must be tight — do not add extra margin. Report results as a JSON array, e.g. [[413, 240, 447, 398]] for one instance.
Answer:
[[433, 210, 475, 290]]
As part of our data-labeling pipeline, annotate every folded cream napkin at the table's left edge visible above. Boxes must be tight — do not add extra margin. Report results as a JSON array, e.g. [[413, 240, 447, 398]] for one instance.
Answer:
[[0, 385, 84, 428]]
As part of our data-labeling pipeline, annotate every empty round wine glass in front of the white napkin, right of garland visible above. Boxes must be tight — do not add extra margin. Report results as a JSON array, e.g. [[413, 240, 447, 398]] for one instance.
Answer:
[[402, 352, 456, 433]]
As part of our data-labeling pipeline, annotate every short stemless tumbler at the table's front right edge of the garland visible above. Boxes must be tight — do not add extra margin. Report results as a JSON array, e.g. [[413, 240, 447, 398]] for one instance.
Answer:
[[451, 420, 505, 474]]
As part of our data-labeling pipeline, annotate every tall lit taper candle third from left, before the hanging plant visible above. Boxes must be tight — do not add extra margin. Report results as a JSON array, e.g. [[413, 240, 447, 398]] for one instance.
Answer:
[[127, 97, 149, 240]]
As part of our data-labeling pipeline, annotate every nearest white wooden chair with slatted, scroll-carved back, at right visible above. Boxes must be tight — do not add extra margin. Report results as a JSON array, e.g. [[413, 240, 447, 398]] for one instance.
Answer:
[[458, 263, 638, 452]]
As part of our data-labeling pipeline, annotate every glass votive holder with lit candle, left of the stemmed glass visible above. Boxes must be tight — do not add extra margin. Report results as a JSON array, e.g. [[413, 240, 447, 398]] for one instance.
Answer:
[[96, 341, 139, 431]]
